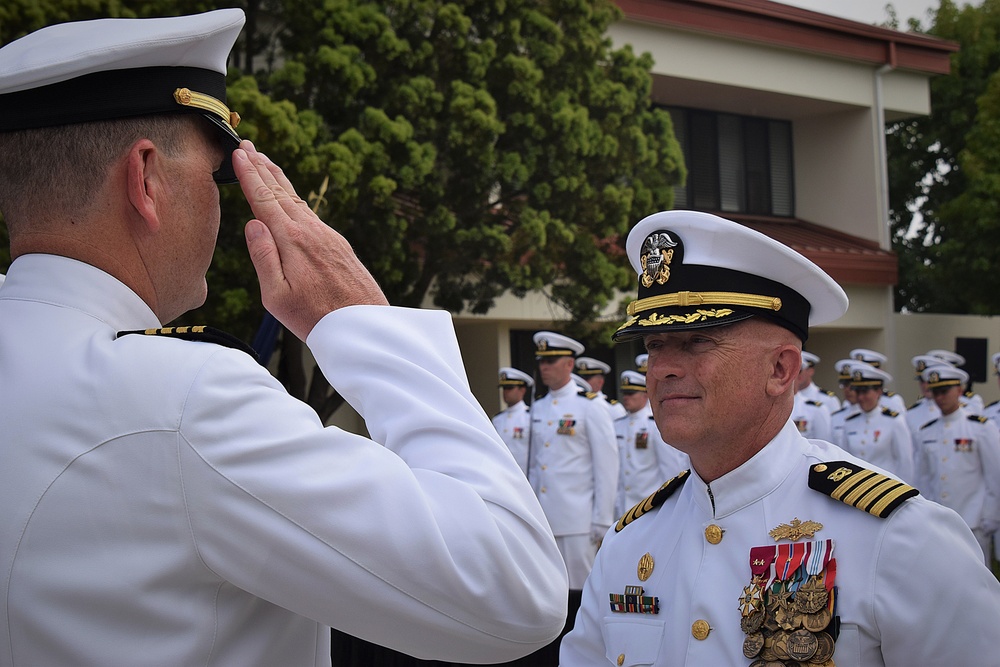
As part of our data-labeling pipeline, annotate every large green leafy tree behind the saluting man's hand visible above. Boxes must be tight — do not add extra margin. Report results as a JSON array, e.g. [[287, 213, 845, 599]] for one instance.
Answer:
[[0, 0, 684, 417]]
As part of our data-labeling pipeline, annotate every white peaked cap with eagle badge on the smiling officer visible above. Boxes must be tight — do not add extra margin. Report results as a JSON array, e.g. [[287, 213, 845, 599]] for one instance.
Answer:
[[612, 211, 847, 342]]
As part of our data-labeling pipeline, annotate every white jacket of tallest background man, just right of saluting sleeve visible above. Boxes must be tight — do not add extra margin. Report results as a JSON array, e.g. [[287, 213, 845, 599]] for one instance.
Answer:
[[528, 382, 618, 536]]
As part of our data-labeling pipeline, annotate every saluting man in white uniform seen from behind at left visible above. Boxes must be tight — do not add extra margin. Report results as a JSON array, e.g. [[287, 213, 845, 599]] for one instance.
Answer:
[[0, 9, 567, 667]]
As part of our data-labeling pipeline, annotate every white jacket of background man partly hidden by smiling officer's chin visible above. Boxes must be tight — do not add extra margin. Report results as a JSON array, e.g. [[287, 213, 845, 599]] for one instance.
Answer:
[[615, 403, 691, 517]]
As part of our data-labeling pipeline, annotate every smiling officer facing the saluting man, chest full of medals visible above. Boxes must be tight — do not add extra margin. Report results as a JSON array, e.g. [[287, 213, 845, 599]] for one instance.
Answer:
[[559, 211, 1000, 667]]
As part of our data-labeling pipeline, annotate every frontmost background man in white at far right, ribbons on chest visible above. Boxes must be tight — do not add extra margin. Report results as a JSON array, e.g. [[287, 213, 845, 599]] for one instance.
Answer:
[[914, 365, 1000, 565]]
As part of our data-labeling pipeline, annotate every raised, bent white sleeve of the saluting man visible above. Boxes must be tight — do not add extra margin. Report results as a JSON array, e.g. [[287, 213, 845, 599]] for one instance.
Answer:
[[180, 306, 568, 662]]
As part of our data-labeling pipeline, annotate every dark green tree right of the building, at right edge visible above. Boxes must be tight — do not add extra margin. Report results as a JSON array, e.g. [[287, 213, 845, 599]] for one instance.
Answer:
[[888, 0, 1000, 314]]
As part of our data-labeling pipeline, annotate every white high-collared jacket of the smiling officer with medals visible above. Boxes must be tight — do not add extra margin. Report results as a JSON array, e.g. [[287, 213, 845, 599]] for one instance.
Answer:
[[560, 421, 1000, 667]]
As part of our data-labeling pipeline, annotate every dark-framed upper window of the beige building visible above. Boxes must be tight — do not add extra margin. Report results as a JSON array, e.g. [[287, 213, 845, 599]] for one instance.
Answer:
[[665, 107, 795, 217]]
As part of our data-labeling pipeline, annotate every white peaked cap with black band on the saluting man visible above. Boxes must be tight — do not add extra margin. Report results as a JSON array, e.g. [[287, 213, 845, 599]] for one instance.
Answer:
[[0, 9, 245, 183]]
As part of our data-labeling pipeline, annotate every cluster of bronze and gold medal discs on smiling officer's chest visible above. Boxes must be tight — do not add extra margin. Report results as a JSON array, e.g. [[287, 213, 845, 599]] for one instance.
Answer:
[[740, 575, 836, 667]]
